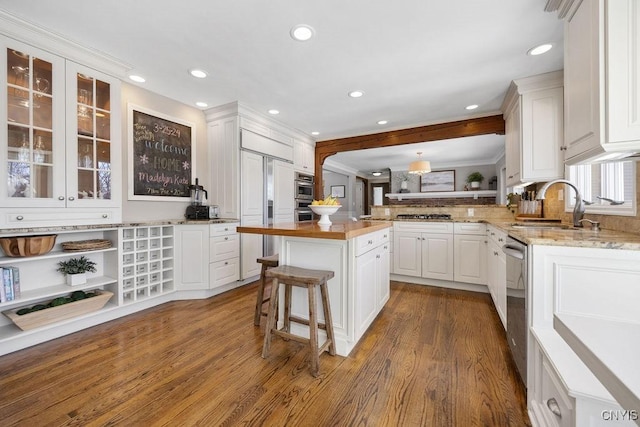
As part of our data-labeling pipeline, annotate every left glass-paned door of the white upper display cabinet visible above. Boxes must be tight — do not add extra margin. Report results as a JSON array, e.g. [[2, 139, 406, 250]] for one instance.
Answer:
[[0, 39, 65, 206]]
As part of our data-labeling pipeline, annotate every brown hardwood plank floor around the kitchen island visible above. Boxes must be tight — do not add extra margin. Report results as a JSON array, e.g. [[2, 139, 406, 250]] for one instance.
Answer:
[[0, 282, 530, 427]]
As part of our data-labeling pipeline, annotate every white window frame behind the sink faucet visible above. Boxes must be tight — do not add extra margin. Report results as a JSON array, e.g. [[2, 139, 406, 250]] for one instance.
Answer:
[[564, 159, 638, 216]]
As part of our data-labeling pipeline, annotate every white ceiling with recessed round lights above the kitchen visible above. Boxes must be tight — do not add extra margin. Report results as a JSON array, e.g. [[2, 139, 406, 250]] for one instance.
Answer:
[[0, 0, 563, 170]]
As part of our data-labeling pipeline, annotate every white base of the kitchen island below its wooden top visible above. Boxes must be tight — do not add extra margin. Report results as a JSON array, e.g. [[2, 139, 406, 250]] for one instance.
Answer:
[[279, 230, 390, 356]]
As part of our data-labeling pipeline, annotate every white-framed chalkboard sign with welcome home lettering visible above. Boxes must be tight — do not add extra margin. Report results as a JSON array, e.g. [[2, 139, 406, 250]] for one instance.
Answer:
[[129, 105, 195, 202]]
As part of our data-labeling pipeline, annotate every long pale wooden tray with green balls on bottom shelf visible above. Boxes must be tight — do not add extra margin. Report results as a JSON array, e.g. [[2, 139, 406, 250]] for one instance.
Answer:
[[3, 289, 113, 331]]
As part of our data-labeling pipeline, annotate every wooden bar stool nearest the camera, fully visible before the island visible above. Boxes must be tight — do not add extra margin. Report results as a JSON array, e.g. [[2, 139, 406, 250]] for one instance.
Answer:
[[262, 265, 336, 377]]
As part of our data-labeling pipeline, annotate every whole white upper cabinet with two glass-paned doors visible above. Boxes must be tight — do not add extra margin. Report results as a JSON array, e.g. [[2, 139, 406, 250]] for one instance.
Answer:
[[0, 37, 121, 224]]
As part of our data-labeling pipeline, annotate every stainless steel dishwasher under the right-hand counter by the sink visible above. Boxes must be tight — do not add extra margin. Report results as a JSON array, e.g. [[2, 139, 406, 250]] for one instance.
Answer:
[[502, 237, 529, 386]]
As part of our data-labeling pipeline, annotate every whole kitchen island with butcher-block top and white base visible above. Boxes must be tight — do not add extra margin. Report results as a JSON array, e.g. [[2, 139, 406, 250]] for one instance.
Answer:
[[238, 221, 393, 356]]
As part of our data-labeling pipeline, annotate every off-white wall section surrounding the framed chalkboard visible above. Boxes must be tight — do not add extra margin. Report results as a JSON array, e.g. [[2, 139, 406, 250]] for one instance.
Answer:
[[122, 82, 210, 222]]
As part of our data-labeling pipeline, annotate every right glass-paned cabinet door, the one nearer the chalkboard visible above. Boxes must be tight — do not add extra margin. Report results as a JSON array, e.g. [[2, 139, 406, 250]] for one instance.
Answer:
[[67, 63, 117, 206]]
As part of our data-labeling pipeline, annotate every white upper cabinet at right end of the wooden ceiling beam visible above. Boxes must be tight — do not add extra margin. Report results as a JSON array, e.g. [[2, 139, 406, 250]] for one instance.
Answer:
[[503, 71, 564, 186]]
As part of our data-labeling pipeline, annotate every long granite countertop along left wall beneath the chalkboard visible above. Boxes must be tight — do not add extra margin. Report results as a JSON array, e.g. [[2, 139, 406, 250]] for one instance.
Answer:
[[0, 218, 240, 237]]
